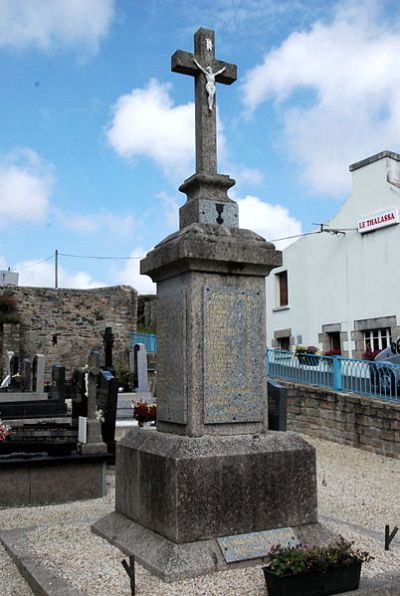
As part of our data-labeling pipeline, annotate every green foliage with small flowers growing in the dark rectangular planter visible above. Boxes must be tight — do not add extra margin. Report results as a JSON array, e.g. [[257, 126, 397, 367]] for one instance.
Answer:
[[266, 538, 373, 576]]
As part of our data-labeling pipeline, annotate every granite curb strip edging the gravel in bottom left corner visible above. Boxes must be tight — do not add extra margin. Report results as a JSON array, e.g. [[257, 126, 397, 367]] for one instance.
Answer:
[[0, 528, 84, 596]]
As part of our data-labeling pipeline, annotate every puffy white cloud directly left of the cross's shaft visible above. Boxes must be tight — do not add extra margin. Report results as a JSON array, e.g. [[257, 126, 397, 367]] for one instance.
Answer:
[[107, 79, 194, 171]]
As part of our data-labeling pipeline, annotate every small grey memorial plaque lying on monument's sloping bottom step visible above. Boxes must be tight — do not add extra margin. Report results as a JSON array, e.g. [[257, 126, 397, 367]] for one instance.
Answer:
[[217, 528, 300, 563]]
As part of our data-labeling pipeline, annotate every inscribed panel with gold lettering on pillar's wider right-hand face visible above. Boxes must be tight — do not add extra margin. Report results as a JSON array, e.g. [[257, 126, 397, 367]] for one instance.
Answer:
[[204, 287, 265, 424]]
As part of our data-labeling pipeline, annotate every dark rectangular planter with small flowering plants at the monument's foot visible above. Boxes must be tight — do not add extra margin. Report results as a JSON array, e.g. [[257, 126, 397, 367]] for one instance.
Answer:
[[263, 538, 372, 596]]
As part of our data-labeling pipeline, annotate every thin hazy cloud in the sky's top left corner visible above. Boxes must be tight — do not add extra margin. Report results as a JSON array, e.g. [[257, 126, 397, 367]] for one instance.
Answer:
[[0, 0, 115, 53]]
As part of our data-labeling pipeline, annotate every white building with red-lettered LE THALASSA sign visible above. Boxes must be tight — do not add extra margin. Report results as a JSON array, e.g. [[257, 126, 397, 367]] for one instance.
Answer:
[[267, 151, 400, 358]]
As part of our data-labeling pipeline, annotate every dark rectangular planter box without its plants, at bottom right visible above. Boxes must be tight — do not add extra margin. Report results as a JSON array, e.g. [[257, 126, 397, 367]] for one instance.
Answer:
[[263, 561, 361, 596]]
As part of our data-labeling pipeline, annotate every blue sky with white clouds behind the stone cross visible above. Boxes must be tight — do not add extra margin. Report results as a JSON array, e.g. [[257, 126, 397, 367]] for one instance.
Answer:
[[0, 0, 400, 292]]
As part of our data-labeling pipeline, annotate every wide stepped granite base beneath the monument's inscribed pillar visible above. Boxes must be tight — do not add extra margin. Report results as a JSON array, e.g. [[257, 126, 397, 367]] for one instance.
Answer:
[[92, 428, 334, 581]]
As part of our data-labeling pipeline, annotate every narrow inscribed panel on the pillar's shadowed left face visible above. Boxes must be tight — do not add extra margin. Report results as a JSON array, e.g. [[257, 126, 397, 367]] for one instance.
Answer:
[[157, 285, 187, 424]]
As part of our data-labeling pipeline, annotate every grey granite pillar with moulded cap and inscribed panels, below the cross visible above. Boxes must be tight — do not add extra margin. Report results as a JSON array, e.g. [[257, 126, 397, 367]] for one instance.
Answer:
[[141, 223, 281, 436]]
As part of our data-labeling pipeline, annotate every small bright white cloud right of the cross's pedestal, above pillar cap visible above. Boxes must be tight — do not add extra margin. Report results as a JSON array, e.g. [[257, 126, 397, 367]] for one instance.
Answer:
[[236, 195, 302, 250]]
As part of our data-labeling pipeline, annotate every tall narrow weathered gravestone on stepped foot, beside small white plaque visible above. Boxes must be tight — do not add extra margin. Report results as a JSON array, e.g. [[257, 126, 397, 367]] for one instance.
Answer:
[[80, 350, 107, 455]]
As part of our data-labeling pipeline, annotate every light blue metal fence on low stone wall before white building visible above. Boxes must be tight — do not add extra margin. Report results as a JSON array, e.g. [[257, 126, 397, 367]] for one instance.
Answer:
[[267, 349, 400, 401]]
